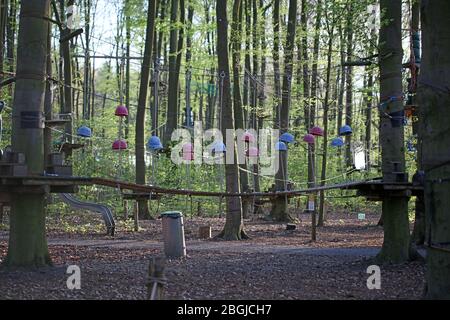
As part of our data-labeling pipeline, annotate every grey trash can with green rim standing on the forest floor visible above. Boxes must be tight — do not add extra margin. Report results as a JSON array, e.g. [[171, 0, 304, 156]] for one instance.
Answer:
[[161, 211, 186, 258]]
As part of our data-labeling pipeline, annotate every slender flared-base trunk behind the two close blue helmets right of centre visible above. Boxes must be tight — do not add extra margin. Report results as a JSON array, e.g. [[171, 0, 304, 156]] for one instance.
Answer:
[[270, 0, 297, 221]]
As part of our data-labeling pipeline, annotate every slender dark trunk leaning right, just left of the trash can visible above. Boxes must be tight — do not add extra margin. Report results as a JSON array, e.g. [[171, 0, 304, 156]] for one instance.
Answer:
[[135, 0, 157, 219]]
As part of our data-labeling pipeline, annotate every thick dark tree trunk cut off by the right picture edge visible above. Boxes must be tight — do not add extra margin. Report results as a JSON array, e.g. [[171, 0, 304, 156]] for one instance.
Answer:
[[419, 0, 450, 299]]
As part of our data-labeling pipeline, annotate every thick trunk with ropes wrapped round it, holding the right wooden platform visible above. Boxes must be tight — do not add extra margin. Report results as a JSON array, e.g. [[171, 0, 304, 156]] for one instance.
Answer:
[[378, 0, 410, 263]]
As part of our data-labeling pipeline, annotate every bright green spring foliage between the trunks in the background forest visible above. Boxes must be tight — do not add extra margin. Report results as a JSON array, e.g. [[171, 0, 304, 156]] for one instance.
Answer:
[[0, 0, 415, 221]]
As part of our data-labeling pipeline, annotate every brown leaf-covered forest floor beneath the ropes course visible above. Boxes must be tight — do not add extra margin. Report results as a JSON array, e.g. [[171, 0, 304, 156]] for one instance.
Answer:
[[0, 209, 425, 299]]
